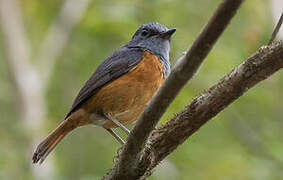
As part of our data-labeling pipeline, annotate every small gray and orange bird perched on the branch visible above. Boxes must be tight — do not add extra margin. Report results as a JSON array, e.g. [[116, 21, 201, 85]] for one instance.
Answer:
[[32, 22, 176, 164]]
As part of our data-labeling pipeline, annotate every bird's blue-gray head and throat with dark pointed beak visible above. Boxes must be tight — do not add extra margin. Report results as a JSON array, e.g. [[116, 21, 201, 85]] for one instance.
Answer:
[[126, 22, 176, 76]]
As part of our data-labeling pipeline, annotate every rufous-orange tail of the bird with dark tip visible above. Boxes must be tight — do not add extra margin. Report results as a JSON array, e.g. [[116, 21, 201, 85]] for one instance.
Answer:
[[32, 119, 76, 164]]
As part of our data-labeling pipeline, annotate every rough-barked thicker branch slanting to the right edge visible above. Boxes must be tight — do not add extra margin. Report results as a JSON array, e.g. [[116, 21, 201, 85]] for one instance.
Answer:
[[139, 42, 283, 177]]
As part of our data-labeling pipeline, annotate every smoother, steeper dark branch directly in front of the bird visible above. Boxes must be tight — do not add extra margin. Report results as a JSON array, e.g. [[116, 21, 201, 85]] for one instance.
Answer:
[[104, 0, 243, 179]]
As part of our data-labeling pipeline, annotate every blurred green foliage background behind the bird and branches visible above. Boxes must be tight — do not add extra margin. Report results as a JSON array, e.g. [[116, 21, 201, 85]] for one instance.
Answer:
[[0, 0, 283, 180]]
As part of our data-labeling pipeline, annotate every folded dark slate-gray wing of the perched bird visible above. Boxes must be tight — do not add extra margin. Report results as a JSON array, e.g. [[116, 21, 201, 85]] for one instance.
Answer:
[[65, 47, 143, 119]]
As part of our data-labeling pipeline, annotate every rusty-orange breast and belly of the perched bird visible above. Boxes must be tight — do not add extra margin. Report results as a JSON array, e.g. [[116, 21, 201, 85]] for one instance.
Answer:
[[83, 51, 164, 128]]
